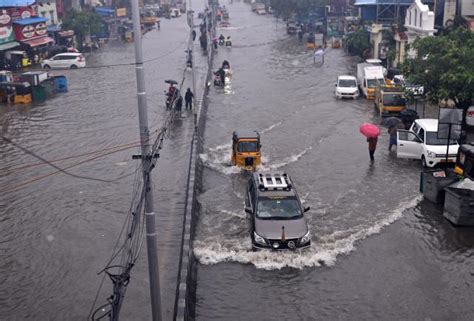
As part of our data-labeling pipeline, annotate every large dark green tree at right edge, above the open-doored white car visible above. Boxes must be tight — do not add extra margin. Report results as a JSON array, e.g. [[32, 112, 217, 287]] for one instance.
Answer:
[[402, 28, 474, 121]]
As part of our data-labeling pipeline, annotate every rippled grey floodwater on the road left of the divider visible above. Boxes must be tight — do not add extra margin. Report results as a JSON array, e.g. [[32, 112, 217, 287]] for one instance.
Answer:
[[0, 4, 206, 321]]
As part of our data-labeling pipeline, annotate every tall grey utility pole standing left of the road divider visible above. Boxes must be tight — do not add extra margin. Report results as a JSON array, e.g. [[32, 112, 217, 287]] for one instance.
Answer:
[[131, 0, 161, 321]]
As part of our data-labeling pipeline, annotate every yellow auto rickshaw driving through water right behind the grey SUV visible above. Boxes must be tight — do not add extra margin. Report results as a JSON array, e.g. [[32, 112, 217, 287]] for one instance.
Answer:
[[232, 131, 262, 171]]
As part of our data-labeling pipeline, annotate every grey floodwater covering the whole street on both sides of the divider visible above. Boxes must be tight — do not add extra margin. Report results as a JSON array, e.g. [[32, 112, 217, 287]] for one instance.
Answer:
[[0, 1, 474, 321]]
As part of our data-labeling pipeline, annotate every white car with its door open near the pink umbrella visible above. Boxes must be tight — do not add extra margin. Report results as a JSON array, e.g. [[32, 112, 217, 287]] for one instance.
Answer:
[[397, 119, 459, 167]]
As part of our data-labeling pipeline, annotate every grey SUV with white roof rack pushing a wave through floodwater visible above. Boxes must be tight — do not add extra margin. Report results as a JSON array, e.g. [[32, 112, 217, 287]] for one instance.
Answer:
[[245, 172, 311, 250]]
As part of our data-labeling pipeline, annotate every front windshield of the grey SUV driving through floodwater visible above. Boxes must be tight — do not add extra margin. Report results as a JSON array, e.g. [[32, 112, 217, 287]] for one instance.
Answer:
[[257, 197, 303, 220]]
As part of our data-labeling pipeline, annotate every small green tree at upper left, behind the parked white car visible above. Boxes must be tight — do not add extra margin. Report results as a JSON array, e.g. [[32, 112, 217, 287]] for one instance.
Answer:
[[62, 10, 104, 48]]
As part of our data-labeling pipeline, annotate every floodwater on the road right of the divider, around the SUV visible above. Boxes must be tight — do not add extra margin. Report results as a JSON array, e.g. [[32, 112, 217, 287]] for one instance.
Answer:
[[194, 2, 474, 320]]
